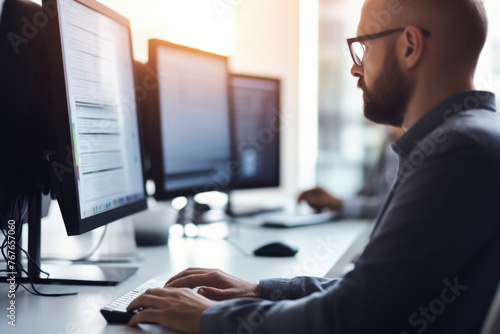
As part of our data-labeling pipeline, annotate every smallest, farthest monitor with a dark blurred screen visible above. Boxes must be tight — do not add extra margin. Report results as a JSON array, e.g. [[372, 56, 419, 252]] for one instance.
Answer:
[[231, 74, 280, 189]]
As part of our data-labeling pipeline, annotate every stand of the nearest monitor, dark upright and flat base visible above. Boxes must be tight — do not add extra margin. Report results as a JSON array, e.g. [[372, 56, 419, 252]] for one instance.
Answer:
[[0, 189, 138, 286]]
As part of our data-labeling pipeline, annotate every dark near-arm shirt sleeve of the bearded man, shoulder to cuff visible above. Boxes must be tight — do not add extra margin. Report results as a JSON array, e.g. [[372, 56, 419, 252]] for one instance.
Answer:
[[201, 134, 498, 334]]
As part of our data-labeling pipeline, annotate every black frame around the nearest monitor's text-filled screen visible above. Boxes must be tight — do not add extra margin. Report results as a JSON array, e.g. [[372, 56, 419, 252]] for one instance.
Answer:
[[43, 0, 147, 235]]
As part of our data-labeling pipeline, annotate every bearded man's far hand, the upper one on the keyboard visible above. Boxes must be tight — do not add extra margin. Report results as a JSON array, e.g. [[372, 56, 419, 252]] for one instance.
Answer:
[[165, 268, 259, 300]]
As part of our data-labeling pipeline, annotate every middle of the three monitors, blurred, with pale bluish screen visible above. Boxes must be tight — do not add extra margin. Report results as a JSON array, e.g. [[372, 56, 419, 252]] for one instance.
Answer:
[[145, 40, 232, 199]]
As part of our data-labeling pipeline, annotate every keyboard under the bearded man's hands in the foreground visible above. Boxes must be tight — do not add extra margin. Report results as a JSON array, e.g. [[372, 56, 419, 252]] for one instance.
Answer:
[[101, 276, 168, 324]]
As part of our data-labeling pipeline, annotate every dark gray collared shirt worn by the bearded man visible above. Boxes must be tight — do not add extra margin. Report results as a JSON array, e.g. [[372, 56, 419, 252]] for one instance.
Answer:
[[201, 91, 500, 334]]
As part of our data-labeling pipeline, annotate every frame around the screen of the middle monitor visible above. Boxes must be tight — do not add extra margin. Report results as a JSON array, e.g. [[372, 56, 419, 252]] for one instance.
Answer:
[[143, 39, 235, 201]]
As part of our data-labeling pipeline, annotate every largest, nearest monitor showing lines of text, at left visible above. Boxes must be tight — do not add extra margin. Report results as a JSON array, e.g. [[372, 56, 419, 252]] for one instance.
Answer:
[[45, 0, 146, 234]]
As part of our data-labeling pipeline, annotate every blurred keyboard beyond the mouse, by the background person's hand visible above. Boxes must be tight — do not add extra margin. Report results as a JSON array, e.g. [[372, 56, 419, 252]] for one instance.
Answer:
[[262, 212, 338, 228]]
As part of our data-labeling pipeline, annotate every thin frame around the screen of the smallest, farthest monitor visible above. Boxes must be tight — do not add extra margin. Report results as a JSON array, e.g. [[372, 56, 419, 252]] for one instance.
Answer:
[[229, 73, 282, 190]]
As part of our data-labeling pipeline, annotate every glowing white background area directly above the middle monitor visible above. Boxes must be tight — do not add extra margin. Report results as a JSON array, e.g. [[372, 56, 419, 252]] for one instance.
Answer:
[[99, 0, 235, 62]]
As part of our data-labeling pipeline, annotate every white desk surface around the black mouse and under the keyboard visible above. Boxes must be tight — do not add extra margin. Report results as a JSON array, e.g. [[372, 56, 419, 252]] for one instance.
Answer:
[[0, 221, 371, 334]]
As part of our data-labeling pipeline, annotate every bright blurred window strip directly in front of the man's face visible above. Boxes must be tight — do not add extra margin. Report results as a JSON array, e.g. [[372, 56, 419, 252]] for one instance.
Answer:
[[317, 0, 376, 198]]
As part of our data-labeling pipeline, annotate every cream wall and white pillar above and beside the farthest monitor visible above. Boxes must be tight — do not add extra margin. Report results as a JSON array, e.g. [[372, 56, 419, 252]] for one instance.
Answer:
[[232, 0, 318, 201]]
